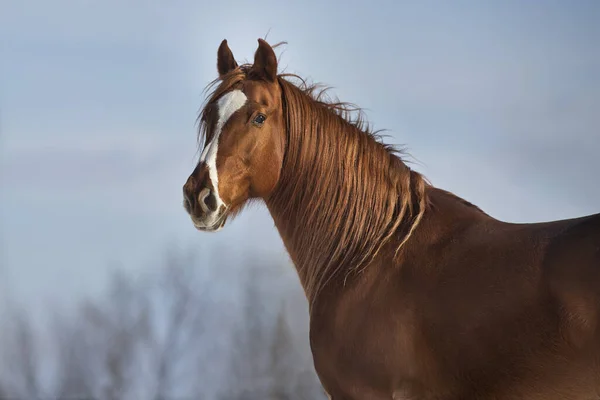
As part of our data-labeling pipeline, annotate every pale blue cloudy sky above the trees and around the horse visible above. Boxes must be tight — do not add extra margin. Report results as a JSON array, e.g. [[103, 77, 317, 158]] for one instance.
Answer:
[[0, 0, 600, 307]]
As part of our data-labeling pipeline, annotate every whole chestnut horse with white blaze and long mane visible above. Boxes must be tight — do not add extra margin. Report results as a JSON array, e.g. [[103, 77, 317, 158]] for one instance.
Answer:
[[183, 39, 600, 400]]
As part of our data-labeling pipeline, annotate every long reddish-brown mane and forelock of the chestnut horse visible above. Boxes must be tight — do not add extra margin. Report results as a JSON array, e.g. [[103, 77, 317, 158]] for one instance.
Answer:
[[199, 64, 429, 298]]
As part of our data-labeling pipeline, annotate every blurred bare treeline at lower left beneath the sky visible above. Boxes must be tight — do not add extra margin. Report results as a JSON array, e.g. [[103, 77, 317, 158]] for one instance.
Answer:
[[0, 247, 325, 400]]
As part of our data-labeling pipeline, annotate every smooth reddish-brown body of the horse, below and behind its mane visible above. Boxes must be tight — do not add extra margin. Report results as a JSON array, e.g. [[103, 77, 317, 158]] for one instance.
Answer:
[[311, 189, 600, 400]]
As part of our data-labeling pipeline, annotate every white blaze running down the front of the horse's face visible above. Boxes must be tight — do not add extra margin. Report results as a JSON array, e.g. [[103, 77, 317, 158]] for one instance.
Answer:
[[200, 90, 247, 210]]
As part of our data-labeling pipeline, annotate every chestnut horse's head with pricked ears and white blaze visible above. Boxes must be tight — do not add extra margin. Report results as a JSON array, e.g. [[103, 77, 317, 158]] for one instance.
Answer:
[[183, 39, 285, 231]]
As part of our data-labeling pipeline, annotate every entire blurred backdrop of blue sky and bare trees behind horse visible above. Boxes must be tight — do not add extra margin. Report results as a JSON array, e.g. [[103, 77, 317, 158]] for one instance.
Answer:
[[0, 0, 600, 400]]
